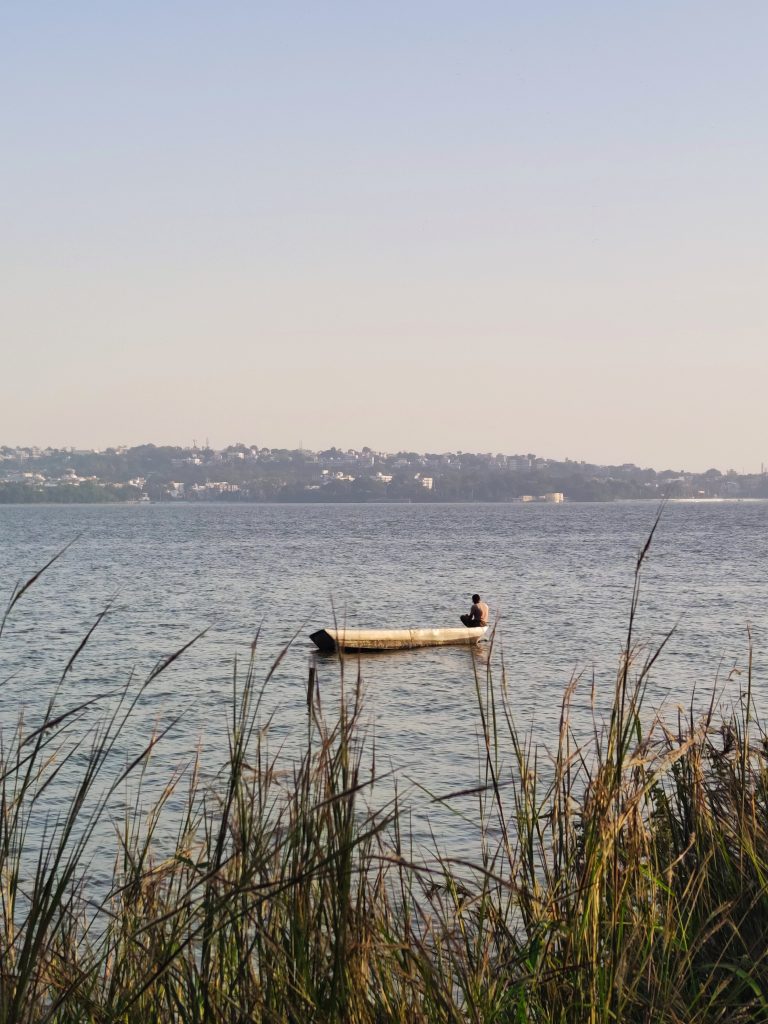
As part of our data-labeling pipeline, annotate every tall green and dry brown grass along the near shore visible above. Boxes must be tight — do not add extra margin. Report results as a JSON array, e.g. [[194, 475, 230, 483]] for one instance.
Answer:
[[0, 532, 768, 1024]]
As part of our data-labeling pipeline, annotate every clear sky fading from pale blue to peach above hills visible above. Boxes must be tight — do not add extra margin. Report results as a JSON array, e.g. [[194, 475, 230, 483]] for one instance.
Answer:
[[0, 0, 768, 472]]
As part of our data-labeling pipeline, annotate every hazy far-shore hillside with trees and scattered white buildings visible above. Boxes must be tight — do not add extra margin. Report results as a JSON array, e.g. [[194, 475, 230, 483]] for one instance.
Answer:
[[0, 444, 768, 504]]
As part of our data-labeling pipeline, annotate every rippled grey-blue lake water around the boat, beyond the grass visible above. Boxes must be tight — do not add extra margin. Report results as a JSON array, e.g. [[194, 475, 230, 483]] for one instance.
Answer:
[[0, 502, 768, 860]]
